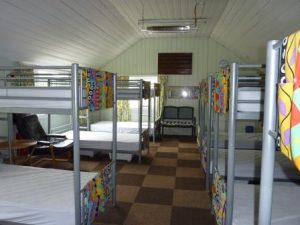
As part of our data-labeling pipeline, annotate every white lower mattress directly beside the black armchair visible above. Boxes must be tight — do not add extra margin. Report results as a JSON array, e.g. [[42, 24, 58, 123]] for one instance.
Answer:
[[63, 131, 139, 152]]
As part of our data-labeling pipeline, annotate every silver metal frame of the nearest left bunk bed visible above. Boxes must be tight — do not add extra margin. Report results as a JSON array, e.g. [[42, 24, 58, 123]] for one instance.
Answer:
[[0, 63, 117, 225]]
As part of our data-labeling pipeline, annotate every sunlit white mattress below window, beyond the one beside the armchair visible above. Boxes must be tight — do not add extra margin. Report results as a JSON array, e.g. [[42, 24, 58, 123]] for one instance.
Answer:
[[91, 121, 153, 134]]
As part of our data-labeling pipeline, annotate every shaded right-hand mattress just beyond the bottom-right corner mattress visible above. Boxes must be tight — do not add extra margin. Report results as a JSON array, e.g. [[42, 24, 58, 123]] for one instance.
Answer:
[[218, 149, 300, 180]]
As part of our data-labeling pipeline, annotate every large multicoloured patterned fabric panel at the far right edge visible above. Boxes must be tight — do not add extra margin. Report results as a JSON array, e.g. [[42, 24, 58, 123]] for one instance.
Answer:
[[278, 31, 300, 170]]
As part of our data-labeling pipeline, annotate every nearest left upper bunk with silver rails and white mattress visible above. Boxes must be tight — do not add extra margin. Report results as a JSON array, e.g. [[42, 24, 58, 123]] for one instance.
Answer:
[[0, 64, 88, 114]]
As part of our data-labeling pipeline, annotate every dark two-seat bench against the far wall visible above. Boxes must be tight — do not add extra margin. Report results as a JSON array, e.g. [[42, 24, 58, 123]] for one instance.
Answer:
[[161, 106, 196, 136]]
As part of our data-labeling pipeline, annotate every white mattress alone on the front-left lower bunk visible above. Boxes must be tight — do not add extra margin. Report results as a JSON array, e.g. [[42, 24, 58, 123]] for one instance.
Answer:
[[0, 163, 96, 225]]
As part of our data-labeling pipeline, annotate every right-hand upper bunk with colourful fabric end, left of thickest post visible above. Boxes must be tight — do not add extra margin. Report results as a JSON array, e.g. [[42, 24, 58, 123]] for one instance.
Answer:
[[212, 63, 264, 120]]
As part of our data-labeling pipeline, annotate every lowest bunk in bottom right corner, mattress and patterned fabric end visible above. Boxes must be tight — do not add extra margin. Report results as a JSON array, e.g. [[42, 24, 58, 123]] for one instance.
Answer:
[[212, 173, 300, 225]]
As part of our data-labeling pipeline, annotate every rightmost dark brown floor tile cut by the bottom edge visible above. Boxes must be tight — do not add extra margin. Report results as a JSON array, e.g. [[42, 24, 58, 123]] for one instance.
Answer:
[[171, 207, 216, 225]]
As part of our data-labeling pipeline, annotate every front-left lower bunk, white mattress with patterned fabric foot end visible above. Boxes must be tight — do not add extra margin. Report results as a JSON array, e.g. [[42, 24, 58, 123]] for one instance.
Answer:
[[0, 163, 112, 225]]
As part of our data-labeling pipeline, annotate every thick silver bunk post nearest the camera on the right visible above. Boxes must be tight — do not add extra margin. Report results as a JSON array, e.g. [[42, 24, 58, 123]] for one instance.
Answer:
[[258, 40, 279, 225]]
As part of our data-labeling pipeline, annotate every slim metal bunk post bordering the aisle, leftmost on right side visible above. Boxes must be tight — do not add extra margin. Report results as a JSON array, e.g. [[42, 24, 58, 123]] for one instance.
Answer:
[[205, 76, 212, 191]]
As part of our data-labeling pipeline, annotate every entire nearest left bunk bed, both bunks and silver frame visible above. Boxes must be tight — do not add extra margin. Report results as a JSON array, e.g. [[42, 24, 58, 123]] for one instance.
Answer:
[[0, 64, 116, 225]]
